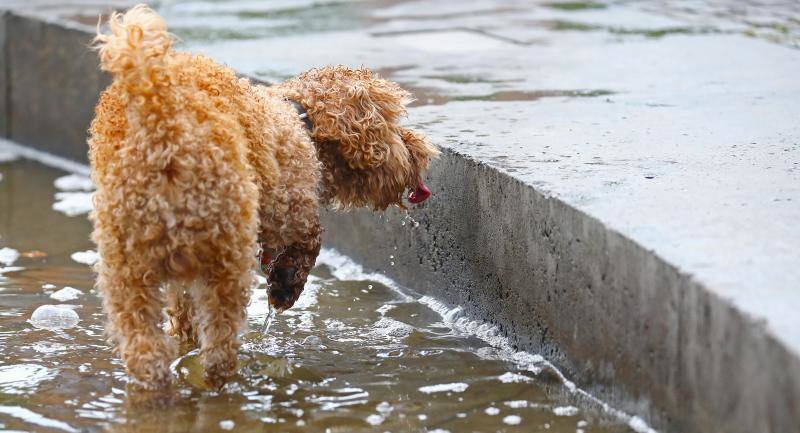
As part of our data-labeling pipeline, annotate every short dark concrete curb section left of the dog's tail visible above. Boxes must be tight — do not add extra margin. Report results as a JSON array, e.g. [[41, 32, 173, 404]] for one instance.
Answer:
[[0, 12, 110, 161]]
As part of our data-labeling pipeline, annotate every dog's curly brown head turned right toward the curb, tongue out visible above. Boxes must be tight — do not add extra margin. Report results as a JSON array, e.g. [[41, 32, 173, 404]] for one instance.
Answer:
[[280, 66, 439, 209]]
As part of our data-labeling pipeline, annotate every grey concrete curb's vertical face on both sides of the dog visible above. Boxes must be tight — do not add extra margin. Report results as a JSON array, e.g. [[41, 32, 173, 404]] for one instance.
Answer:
[[0, 9, 800, 433]]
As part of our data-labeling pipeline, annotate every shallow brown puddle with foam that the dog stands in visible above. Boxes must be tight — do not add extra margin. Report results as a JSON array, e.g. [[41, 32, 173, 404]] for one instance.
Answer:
[[0, 147, 647, 433]]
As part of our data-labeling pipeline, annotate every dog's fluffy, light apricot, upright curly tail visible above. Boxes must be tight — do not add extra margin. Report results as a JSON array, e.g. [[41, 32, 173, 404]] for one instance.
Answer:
[[94, 4, 173, 95]]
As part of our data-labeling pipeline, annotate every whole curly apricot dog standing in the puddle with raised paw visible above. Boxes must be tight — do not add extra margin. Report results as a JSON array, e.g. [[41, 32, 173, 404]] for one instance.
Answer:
[[89, 5, 437, 388]]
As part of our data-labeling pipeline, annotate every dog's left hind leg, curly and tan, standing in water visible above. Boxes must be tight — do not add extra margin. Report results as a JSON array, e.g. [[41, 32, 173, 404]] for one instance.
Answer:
[[97, 253, 175, 389]]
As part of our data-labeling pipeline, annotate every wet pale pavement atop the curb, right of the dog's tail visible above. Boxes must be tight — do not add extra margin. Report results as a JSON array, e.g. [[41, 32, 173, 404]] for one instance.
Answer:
[[138, 0, 800, 352]]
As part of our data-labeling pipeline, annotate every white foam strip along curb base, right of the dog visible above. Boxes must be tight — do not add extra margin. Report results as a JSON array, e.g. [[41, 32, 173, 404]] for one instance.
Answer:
[[317, 248, 657, 433]]
